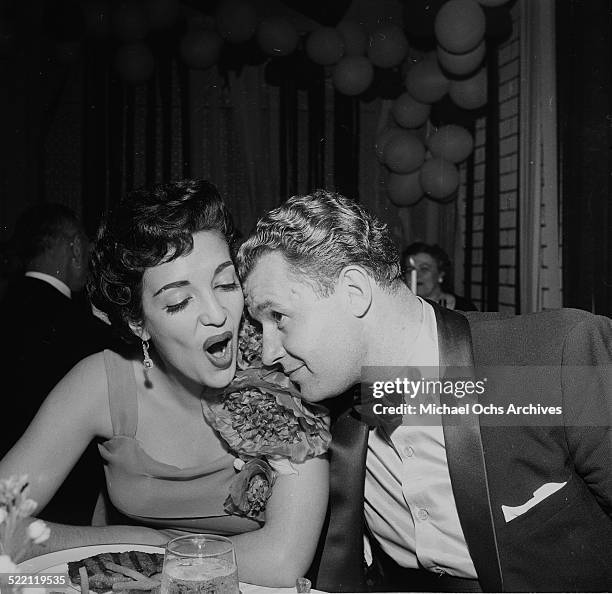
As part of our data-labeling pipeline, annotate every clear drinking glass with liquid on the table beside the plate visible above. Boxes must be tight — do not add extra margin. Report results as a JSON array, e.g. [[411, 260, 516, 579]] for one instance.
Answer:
[[161, 534, 239, 594]]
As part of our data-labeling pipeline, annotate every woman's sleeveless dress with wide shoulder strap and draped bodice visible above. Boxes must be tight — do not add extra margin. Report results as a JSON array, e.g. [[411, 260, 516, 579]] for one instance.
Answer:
[[98, 351, 260, 535]]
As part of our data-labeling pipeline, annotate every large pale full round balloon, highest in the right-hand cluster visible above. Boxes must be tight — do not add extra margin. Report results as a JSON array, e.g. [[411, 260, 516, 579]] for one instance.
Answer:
[[435, 0, 486, 54]]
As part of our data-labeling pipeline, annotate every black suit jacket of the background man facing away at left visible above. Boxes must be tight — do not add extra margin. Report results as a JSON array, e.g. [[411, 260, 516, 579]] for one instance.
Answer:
[[0, 277, 122, 524]]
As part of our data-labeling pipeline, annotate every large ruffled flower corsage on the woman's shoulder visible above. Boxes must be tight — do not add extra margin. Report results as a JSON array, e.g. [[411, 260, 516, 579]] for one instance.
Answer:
[[203, 319, 331, 522]]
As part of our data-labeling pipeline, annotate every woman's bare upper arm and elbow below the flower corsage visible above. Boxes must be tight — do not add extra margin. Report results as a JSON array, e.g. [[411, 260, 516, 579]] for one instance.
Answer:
[[231, 457, 329, 587]]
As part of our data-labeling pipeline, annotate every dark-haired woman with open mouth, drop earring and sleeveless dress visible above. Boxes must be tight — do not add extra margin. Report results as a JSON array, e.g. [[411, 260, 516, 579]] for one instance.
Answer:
[[0, 181, 328, 586]]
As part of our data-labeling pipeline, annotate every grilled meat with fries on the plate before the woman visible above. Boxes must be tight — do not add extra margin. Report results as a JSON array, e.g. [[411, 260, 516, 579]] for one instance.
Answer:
[[68, 551, 164, 594]]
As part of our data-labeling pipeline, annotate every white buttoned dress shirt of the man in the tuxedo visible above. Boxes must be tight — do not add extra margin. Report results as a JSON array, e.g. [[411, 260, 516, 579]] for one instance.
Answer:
[[365, 299, 477, 578]]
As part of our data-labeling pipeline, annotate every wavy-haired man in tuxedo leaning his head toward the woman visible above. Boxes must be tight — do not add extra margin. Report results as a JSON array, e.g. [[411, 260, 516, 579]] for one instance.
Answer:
[[238, 191, 612, 591]]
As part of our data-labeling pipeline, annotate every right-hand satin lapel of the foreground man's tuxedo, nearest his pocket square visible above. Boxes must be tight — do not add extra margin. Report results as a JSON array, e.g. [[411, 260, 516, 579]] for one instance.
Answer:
[[432, 304, 503, 592]]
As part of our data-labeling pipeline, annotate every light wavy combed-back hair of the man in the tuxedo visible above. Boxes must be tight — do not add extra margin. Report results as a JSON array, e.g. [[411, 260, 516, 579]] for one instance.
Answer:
[[237, 190, 402, 297]]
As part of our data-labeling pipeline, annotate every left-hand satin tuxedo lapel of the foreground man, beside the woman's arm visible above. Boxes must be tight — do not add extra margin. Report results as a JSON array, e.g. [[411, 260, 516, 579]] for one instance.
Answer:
[[312, 412, 369, 592]]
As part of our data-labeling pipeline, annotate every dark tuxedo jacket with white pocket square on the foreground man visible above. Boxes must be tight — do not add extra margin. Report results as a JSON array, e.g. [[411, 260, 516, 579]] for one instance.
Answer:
[[311, 306, 612, 591]]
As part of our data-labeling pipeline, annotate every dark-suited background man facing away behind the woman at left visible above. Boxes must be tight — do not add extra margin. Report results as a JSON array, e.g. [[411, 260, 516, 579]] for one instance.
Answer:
[[0, 203, 119, 524]]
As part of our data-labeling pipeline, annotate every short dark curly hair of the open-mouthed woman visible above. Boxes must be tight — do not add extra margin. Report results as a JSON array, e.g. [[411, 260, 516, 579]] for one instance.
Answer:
[[87, 180, 234, 342]]
